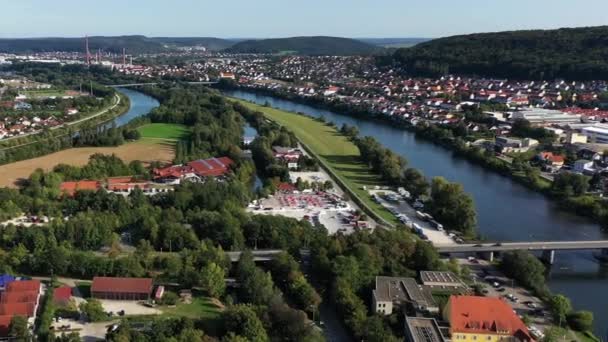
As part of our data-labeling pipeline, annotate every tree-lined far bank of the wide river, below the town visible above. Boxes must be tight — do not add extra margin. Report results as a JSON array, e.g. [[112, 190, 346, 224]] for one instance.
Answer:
[[221, 86, 608, 230]]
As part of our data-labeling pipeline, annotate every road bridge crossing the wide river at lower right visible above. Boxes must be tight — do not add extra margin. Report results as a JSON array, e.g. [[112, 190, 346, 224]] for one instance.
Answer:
[[435, 240, 608, 264]]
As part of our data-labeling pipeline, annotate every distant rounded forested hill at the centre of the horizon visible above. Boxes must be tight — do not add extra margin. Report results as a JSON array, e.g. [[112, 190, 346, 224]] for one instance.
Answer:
[[226, 36, 382, 56]]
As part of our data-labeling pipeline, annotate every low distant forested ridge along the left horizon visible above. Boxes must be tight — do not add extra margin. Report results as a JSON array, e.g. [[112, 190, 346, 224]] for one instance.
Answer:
[[0, 36, 232, 54]]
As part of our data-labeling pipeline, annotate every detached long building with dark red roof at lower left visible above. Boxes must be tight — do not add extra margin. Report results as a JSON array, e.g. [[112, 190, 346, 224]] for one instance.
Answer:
[[91, 277, 152, 300]]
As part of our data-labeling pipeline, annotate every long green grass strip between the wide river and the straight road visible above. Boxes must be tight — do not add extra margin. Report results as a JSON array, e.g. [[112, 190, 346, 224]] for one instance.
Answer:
[[232, 99, 398, 224]]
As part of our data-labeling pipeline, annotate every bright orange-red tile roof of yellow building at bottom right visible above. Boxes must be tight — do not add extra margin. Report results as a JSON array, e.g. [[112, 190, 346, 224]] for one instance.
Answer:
[[449, 296, 533, 341]]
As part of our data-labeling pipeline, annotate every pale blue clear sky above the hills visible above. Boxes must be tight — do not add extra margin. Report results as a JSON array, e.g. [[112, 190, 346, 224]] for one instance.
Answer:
[[0, 0, 608, 38]]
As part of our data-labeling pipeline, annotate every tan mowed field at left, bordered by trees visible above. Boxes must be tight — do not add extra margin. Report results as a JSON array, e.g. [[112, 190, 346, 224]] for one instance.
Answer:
[[0, 139, 175, 187]]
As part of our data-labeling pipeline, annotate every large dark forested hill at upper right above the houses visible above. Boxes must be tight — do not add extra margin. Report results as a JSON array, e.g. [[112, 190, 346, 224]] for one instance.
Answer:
[[392, 26, 608, 80]]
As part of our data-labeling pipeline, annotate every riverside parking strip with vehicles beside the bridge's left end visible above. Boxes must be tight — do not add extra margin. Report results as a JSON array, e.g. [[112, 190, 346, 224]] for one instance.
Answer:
[[369, 189, 456, 245]]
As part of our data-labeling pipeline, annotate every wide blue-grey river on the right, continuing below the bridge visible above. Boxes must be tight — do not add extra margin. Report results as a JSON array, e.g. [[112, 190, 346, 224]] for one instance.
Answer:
[[226, 90, 608, 336]]
